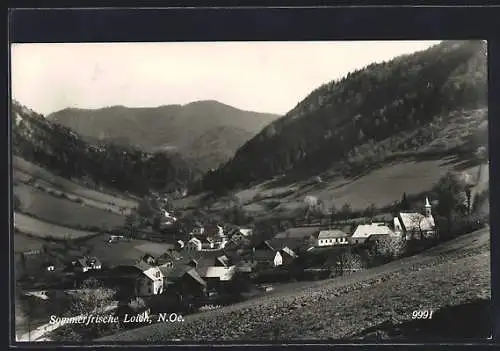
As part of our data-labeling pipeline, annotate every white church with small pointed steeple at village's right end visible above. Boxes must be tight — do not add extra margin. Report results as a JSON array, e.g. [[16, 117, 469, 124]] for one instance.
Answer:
[[394, 198, 438, 240]]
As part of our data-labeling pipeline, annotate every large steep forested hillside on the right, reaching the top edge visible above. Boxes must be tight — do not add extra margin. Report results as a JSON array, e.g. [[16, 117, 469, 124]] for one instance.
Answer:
[[203, 41, 487, 195]]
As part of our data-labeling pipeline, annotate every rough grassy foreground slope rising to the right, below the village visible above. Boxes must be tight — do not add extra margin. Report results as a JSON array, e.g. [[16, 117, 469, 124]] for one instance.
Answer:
[[101, 228, 491, 342]]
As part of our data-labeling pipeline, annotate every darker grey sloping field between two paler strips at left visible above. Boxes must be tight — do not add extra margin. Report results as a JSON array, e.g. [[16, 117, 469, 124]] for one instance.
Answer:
[[14, 184, 125, 229]]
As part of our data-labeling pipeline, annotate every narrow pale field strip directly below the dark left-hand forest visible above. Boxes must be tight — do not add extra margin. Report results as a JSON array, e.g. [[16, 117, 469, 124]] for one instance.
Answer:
[[12, 156, 137, 212]]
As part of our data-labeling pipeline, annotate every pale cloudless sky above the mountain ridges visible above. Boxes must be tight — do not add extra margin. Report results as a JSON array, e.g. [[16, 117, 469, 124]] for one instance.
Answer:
[[11, 41, 439, 114]]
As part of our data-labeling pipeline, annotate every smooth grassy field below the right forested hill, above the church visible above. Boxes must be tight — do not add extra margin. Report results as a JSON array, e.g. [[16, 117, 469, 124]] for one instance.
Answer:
[[180, 155, 489, 217]]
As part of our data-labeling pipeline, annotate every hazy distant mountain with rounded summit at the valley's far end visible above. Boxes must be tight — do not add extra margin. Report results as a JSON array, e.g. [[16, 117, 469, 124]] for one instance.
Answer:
[[47, 101, 278, 169]]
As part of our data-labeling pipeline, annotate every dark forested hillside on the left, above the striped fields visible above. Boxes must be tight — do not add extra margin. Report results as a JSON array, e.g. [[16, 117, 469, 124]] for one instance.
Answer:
[[11, 101, 200, 195]]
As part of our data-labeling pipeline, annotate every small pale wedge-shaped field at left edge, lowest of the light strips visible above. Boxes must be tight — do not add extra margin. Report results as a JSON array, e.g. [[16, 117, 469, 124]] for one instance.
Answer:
[[14, 212, 96, 241]]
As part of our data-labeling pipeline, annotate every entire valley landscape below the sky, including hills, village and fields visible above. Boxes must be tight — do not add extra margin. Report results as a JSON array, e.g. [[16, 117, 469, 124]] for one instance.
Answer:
[[11, 41, 492, 342]]
